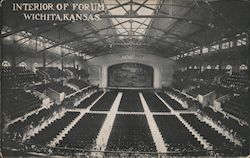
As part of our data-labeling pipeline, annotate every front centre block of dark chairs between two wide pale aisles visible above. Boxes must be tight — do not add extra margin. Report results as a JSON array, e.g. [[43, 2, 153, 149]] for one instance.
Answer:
[[106, 115, 156, 152]]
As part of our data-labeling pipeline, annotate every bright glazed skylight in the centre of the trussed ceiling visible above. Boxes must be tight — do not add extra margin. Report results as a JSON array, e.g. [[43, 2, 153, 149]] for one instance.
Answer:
[[104, 0, 157, 39]]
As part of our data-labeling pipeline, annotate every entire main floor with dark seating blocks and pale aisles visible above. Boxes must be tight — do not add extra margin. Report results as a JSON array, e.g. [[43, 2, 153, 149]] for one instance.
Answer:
[[5, 90, 246, 157]]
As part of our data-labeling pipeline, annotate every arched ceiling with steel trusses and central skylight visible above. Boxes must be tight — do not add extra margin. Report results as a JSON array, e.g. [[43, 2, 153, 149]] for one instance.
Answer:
[[1, 0, 250, 57]]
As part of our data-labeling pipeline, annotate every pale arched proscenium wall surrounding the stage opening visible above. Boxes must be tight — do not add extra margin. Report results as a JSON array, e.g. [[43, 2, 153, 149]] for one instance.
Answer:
[[86, 51, 176, 88]]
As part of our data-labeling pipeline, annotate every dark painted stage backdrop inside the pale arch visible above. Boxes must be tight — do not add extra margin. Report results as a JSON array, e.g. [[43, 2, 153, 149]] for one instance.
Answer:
[[108, 63, 154, 88]]
